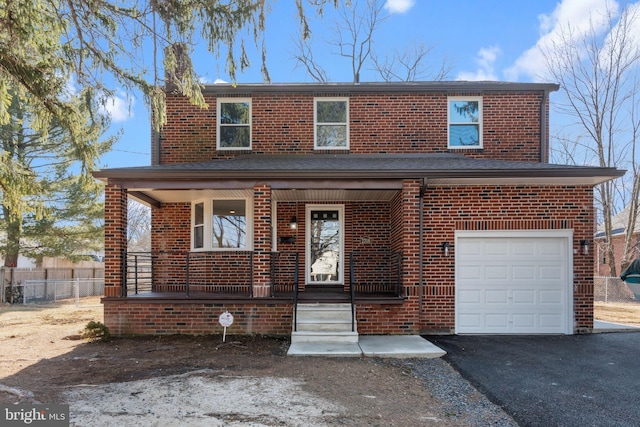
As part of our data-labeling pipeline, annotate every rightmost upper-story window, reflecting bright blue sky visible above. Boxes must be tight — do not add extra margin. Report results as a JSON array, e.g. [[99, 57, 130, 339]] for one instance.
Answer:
[[448, 96, 482, 148]]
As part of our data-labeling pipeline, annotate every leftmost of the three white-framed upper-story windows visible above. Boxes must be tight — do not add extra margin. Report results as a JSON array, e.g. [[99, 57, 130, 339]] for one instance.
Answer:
[[216, 98, 251, 150]]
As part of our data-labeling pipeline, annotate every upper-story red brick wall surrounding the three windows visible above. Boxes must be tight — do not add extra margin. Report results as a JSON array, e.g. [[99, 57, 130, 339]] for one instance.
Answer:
[[159, 92, 543, 164]]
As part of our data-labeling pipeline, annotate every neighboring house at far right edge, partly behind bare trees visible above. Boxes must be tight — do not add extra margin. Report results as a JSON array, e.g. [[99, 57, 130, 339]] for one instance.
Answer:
[[594, 206, 640, 276]]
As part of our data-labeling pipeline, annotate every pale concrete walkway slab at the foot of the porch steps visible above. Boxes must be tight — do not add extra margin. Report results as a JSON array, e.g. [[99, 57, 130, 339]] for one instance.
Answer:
[[287, 335, 446, 359]]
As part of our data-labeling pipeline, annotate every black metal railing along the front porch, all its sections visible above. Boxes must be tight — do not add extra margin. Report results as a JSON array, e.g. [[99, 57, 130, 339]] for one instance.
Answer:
[[121, 251, 402, 303]]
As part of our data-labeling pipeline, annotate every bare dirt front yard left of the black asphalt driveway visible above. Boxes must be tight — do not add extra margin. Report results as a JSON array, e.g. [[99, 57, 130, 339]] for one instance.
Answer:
[[0, 299, 513, 427]]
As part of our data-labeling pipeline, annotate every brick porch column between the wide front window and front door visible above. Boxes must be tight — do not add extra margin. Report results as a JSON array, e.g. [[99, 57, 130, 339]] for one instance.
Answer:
[[253, 184, 271, 298]]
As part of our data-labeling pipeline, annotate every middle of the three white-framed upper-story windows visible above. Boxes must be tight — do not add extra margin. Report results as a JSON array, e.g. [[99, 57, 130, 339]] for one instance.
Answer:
[[314, 98, 349, 150]]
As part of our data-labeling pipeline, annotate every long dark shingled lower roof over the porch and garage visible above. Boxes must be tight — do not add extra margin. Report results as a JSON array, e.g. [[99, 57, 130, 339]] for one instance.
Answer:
[[94, 153, 625, 188]]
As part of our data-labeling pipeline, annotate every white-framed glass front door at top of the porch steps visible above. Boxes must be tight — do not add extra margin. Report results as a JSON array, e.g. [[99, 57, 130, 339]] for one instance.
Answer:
[[306, 205, 344, 285]]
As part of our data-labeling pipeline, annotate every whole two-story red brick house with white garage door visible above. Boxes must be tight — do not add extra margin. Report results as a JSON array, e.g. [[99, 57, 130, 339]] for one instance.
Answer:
[[95, 82, 623, 334]]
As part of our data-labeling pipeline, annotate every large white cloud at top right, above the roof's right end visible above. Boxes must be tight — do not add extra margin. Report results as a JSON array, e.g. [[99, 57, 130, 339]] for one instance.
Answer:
[[504, 0, 619, 81]]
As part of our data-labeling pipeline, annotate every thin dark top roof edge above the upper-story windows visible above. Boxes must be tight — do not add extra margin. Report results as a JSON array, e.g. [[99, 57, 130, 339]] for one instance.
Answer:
[[196, 80, 560, 94]]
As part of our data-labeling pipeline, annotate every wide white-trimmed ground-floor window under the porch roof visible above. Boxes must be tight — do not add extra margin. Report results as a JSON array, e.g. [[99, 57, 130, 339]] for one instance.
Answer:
[[191, 198, 253, 251]]
